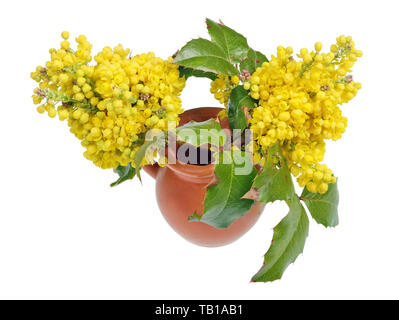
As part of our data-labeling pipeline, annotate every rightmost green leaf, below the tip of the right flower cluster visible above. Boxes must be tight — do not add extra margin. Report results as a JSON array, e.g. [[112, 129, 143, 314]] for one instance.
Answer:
[[301, 183, 339, 227]]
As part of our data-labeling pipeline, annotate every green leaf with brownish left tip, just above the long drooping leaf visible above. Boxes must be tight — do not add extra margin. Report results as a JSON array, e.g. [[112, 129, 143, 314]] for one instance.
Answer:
[[253, 144, 296, 203]]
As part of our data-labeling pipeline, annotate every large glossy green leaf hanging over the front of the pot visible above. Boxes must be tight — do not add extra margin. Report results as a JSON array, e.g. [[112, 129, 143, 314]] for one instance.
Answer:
[[190, 151, 257, 229]]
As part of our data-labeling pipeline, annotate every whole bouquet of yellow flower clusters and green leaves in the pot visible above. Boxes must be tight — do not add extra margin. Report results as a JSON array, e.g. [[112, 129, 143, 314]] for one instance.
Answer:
[[31, 19, 362, 282]]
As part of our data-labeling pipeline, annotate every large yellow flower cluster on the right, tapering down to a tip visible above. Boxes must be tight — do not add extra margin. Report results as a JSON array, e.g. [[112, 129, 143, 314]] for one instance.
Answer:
[[248, 36, 362, 193]]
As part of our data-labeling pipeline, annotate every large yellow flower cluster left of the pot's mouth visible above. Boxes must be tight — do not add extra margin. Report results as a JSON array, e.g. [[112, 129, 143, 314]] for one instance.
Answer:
[[31, 32, 185, 169]]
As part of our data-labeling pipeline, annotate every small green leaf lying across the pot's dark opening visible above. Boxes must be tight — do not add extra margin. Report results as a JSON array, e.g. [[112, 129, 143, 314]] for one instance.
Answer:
[[176, 119, 226, 147]]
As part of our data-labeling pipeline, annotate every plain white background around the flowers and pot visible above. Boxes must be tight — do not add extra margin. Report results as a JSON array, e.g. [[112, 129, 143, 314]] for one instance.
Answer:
[[0, 0, 399, 299]]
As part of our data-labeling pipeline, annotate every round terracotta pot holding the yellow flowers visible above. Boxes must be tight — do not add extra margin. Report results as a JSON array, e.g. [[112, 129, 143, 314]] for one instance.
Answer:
[[144, 108, 264, 247]]
